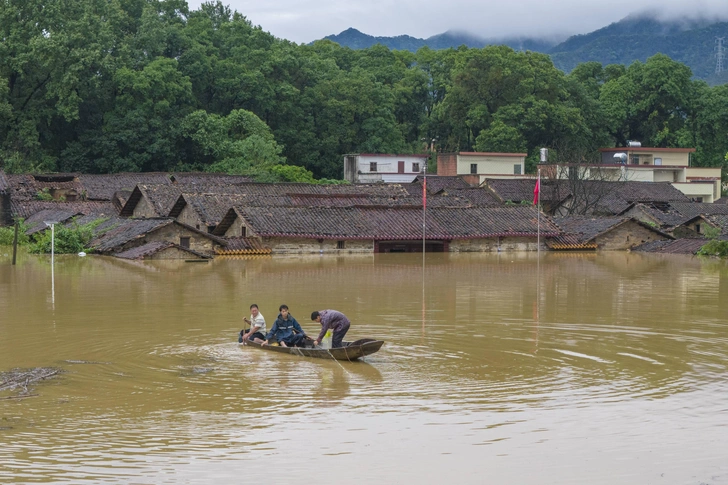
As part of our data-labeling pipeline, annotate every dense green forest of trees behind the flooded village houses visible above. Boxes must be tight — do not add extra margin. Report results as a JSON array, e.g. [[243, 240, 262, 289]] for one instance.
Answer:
[[0, 0, 728, 181]]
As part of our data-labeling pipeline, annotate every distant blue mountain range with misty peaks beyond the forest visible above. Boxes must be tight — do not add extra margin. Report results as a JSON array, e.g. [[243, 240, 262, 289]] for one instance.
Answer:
[[325, 13, 728, 84]]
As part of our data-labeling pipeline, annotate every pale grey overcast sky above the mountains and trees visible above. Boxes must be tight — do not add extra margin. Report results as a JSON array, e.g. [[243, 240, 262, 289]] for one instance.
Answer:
[[188, 0, 728, 43]]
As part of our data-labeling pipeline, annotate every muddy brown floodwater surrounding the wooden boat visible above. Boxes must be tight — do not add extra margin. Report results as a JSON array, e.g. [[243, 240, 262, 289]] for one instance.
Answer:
[[0, 248, 728, 485]]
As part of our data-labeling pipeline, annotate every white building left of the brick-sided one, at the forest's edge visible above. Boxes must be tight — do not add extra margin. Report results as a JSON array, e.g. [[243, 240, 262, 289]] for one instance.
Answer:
[[344, 153, 429, 184]]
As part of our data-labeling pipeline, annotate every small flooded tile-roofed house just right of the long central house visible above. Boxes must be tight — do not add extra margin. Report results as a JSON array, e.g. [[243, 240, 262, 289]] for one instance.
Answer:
[[546, 216, 674, 251]]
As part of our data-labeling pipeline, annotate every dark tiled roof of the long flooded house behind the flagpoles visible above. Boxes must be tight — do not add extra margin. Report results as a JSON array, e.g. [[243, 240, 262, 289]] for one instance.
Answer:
[[239, 207, 560, 240]]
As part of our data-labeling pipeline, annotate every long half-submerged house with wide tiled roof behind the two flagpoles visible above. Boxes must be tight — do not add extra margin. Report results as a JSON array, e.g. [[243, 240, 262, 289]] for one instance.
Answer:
[[219, 206, 561, 254]]
